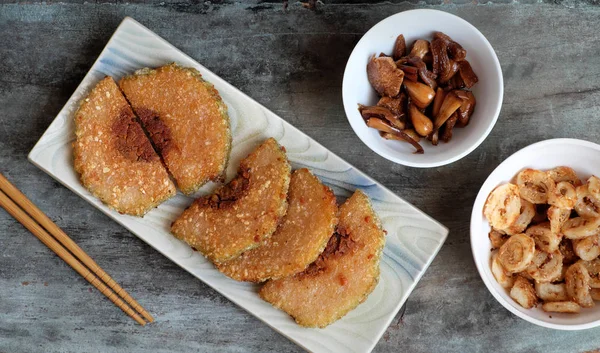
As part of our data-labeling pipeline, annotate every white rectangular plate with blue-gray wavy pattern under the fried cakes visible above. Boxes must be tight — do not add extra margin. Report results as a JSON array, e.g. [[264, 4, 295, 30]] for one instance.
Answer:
[[29, 18, 448, 352]]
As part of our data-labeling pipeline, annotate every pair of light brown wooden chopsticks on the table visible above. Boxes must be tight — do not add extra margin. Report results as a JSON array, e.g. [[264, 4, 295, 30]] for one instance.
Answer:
[[0, 173, 154, 326]]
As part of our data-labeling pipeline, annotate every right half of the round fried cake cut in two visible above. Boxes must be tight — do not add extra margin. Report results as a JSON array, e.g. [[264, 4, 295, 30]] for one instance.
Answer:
[[119, 64, 231, 194]]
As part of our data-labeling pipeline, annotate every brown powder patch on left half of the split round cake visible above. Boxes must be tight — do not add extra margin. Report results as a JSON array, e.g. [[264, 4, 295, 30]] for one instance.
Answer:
[[112, 108, 158, 162]]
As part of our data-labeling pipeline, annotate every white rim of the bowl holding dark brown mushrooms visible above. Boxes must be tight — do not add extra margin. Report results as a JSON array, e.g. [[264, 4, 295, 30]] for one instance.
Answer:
[[342, 9, 504, 168]]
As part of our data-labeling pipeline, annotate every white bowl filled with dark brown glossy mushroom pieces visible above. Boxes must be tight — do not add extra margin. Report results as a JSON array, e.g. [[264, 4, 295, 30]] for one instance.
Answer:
[[342, 10, 504, 168]]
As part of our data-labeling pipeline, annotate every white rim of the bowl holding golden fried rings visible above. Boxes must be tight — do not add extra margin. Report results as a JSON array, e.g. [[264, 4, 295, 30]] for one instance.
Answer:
[[469, 138, 600, 331]]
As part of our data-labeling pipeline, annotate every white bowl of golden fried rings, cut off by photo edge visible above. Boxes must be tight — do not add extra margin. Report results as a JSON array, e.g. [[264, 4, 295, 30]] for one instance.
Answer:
[[471, 139, 600, 330]]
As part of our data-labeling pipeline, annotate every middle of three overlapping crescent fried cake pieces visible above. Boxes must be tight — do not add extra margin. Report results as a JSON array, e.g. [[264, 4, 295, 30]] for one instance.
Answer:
[[217, 169, 337, 282]]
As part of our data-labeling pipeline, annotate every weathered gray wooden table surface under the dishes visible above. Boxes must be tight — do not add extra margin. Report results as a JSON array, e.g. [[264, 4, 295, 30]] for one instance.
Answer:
[[0, 0, 600, 352]]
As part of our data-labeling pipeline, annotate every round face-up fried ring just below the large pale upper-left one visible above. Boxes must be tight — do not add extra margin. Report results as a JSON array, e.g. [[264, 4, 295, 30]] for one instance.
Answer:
[[498, 234, 535, 273]]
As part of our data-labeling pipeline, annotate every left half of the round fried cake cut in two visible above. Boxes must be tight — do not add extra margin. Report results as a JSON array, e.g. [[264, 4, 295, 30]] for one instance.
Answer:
[[73, 77, 175, 216]]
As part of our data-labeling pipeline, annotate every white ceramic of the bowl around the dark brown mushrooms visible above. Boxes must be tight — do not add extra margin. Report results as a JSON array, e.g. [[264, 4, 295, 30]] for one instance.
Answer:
[[342, 10, 504, 168]]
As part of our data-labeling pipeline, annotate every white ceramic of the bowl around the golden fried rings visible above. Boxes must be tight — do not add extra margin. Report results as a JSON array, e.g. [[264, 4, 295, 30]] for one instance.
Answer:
[[471, 139, 600, 330]]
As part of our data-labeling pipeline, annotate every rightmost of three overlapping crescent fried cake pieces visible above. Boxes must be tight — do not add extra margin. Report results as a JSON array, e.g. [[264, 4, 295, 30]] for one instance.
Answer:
[[259, 191, 385, 327]]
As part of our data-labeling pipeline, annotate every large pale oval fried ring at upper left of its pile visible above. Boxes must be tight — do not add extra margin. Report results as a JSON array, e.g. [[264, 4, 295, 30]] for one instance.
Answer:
[[483, 184, 521, 229]]
